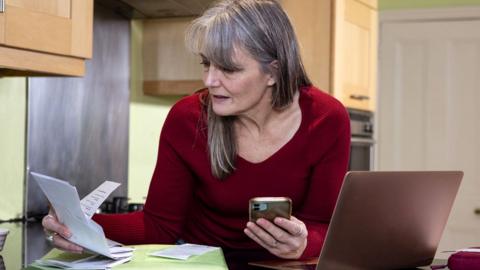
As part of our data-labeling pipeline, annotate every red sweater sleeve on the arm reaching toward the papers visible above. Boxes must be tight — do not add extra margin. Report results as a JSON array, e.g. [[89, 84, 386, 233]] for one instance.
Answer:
[[94, 99, 194, 244]]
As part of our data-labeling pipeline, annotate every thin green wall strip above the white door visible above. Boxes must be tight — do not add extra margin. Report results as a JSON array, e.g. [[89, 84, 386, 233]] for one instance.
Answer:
[[378, 0, 480, 10]]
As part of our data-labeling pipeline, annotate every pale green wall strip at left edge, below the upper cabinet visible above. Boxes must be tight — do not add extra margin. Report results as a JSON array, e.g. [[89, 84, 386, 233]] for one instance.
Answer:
[[0, 78, 27, 220]]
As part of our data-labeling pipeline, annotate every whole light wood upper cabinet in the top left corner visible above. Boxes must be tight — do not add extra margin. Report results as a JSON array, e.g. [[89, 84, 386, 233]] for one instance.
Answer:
[[0, 0, 93, 76]]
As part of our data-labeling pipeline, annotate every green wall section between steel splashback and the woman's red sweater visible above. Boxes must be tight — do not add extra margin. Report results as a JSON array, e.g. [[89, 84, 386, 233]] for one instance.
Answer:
[[128, 20, 180, 203]]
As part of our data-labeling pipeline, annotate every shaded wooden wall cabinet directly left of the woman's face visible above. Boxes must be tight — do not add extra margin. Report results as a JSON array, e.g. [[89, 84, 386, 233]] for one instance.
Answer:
[[142, 17, 204, 95]]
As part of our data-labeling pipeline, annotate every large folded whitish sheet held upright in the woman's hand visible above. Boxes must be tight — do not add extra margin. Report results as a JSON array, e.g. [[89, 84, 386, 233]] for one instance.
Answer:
[[31, 172, 128, 259]]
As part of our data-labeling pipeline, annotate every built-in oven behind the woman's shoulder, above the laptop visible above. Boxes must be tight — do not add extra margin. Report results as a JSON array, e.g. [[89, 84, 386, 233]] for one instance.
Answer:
[[348, 108, 375, 171]]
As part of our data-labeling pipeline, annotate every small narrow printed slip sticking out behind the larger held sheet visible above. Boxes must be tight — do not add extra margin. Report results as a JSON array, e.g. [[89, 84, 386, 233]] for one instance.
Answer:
[[80, 181, 120, 218]]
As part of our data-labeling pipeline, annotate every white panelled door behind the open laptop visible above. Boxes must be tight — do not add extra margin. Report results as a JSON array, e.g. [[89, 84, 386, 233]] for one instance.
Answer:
[[376, 13, 480, 257]]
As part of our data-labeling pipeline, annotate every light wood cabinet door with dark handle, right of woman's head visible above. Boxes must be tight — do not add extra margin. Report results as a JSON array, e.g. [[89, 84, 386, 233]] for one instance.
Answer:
[[333, 0, 378, 111]]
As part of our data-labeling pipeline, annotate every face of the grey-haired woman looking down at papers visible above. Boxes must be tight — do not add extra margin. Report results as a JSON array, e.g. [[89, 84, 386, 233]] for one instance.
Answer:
[[202, 49, 275, 116]]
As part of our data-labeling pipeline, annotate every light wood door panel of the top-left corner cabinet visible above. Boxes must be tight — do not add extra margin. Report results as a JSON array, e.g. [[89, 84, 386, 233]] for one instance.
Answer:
[[0, 0, 93, 58]]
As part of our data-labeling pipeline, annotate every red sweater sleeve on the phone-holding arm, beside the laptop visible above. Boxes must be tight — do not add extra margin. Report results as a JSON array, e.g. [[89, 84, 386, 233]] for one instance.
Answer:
[[297, 106, 350, 258]]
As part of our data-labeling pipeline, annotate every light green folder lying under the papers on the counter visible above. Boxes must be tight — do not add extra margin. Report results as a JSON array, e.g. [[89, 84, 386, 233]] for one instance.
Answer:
[[26, 245, 228, 270]]
